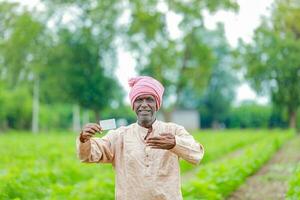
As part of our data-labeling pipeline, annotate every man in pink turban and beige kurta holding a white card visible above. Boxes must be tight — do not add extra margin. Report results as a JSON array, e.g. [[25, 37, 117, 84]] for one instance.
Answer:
[[77, 76, 204, 200]]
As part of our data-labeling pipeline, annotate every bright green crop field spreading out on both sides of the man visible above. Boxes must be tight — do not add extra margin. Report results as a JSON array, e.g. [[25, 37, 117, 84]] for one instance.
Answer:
[[0, 130, 299, 200]]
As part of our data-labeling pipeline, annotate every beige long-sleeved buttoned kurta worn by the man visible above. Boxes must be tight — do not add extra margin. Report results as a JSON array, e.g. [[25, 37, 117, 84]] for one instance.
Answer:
[[77, 120, 204, 200]]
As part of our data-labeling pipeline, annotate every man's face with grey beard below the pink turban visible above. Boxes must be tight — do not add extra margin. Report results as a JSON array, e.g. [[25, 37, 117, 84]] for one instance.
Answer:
[[133, 95, 156, 125]]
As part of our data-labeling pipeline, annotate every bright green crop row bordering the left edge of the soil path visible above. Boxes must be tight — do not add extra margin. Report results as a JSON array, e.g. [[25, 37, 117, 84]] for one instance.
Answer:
[[183, 131, 292, 200]]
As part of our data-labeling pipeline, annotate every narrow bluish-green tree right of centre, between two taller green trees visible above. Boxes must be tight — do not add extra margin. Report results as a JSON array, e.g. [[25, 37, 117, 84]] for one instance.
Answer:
[[198, 24, 238, 128]]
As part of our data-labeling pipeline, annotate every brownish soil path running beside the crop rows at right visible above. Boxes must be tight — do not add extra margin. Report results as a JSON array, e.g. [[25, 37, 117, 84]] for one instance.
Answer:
[[228, 135, 300, 200]]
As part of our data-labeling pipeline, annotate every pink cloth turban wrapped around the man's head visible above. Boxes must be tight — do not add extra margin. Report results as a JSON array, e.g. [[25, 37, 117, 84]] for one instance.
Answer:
[[128, 76, 164, 110]]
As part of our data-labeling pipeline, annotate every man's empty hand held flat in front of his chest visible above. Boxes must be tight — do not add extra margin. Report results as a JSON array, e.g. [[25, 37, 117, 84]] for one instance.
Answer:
[[146, 133, 176, 149]]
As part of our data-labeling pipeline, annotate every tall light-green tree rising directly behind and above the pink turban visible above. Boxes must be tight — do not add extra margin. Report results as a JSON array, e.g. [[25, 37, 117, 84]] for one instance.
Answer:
[[126, 0, 237, 121]]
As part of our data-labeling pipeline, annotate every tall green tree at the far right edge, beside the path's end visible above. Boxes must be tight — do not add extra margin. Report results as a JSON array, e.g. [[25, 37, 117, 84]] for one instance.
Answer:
[[240, 0, 300, 128]]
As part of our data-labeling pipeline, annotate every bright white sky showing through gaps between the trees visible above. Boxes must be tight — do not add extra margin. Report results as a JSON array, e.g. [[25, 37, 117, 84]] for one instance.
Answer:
[[10, 0, 274, 105]]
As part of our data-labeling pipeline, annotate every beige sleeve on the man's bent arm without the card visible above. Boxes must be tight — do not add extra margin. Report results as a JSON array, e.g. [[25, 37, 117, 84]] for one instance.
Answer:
[[170, 126, 204, 164]]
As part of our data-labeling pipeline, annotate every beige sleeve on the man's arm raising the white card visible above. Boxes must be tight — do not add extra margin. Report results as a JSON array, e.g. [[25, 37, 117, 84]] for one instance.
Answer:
[[76, 131, 117, 163]]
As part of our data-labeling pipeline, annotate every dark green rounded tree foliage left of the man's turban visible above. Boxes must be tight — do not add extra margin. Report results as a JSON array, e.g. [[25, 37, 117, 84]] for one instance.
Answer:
[[48, 28, 120, 115]]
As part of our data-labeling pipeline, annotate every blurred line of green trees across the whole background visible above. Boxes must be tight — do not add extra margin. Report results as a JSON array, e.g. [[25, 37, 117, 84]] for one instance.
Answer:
[[0, 0, 300, 132]]
